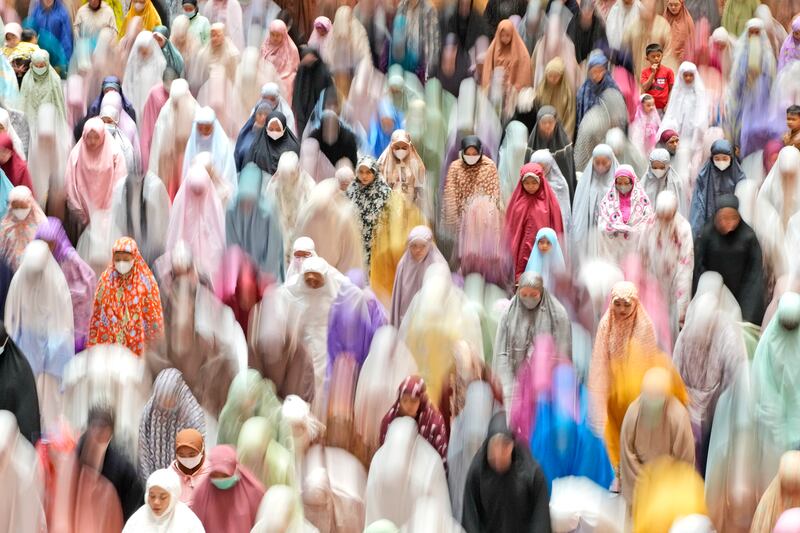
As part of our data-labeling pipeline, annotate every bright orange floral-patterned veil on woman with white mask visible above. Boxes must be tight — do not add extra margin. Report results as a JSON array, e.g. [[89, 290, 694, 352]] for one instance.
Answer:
[[86, 237, 164, 355]]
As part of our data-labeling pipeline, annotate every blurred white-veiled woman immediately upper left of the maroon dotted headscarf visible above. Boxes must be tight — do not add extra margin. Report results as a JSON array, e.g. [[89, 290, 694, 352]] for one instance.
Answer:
[[353, 326, 417, 464]]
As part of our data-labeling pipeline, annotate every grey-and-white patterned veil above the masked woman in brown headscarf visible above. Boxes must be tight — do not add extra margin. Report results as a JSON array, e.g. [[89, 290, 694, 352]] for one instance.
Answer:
[[139, 368, 206, 479]]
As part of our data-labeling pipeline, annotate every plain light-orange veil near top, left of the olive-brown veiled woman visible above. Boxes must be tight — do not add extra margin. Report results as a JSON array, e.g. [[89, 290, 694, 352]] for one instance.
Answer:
[[481, 19, 533, 90]]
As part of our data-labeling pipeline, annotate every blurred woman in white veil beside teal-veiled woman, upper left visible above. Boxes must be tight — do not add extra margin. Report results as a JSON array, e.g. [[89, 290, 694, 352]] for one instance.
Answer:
[[122, 31, 167, 117]]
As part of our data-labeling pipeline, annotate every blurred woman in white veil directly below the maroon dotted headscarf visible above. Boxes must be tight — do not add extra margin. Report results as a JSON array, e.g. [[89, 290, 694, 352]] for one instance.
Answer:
[[366, 416, 451, 524]]
